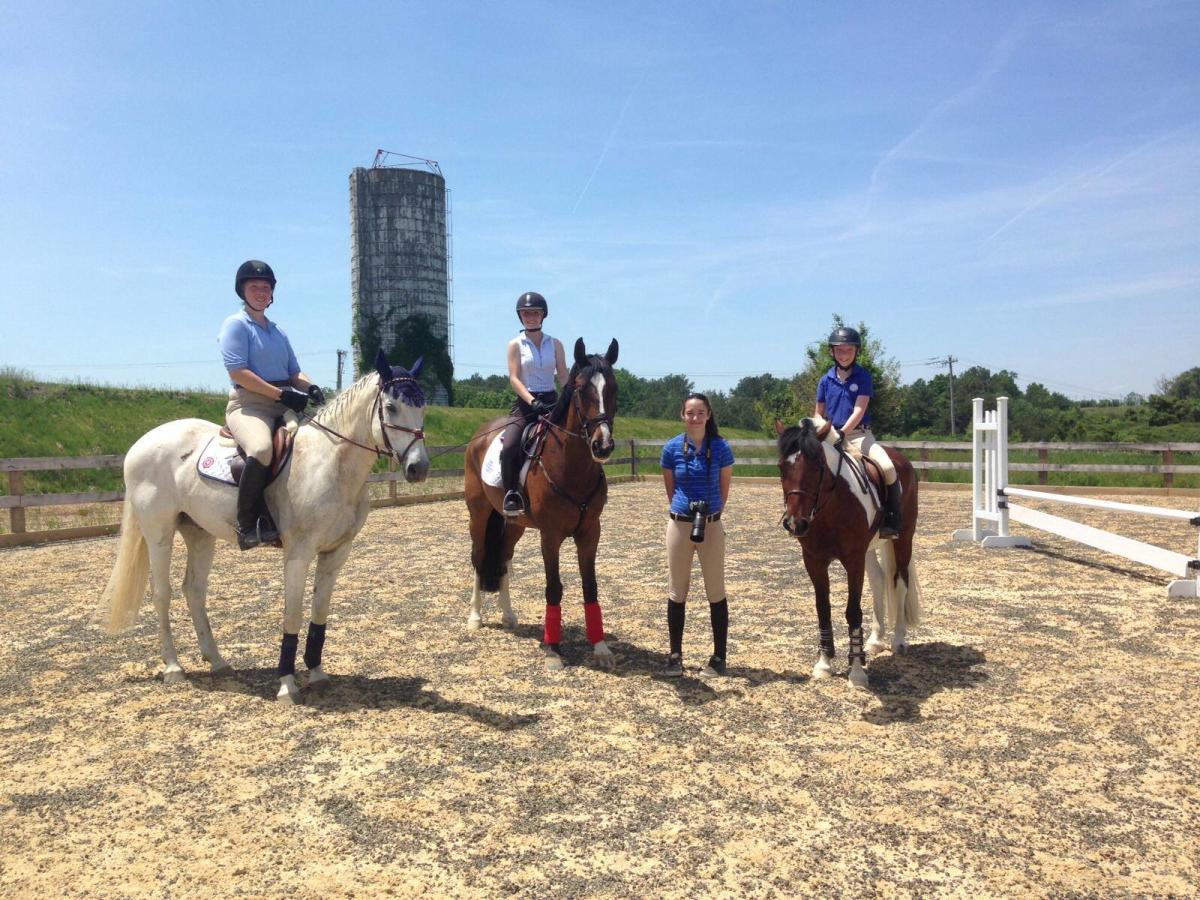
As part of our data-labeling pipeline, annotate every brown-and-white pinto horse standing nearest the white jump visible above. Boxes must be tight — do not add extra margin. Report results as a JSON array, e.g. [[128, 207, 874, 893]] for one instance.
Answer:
[[775, 418, 920, 689]]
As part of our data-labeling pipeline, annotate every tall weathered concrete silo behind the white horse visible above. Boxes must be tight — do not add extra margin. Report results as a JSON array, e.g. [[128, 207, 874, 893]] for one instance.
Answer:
[[350, 157, 454, 403]]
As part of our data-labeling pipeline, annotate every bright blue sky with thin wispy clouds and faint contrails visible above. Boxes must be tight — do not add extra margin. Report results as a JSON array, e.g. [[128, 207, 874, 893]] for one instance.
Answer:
[[0, 0, 1200, 397]]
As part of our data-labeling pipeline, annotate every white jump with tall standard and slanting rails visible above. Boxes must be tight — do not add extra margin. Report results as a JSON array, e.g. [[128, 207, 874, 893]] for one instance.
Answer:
[[953, 397, 1200, 598]]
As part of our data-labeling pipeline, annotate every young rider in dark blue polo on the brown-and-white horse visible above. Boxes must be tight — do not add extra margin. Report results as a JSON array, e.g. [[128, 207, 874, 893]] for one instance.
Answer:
[[816, 326, 901, 538]]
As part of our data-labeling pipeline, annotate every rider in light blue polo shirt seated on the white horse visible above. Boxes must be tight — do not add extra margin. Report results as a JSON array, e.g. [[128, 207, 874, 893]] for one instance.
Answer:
[[217, 259, 325, 550]]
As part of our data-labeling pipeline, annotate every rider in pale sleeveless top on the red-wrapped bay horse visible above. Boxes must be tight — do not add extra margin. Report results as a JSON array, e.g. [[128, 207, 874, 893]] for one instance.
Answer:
[[500, 290, 566, 516]]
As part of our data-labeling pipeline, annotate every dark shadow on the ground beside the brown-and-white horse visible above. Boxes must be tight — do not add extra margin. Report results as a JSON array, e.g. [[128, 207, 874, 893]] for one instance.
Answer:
[[863, 641, 989, 725]]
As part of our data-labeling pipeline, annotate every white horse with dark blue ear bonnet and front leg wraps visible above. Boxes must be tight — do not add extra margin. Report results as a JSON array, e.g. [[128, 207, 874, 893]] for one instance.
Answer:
[[97, 352, 430, 703]]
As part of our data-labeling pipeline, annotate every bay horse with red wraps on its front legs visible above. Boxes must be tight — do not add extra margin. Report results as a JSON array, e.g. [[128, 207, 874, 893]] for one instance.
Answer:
[[464, 337, 617, 670]]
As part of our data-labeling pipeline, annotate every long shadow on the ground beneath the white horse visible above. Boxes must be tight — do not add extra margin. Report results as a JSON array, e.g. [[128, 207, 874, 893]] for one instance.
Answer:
[[177, 668, 541, 731]]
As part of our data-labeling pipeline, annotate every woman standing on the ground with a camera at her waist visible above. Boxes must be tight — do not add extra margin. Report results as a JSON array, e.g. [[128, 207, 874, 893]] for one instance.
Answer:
[[661, 394, 733, 678]]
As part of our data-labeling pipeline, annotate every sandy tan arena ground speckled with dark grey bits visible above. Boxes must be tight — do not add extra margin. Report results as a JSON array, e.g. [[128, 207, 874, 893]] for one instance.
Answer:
[[0, 482, 1200, 898]]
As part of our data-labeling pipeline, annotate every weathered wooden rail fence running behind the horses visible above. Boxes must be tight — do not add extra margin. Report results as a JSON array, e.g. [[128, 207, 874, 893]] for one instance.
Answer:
[[0, 439, 1200, 547]]
